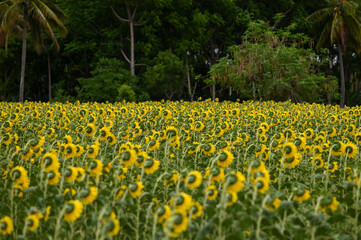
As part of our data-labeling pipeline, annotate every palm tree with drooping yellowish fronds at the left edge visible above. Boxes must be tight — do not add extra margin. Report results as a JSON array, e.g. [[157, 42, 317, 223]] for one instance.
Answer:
[[0, 0, 67, 103]]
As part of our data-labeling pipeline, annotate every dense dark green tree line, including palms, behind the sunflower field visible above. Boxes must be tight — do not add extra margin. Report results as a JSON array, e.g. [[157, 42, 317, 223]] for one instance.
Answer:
[[0, 0, 361, 105]]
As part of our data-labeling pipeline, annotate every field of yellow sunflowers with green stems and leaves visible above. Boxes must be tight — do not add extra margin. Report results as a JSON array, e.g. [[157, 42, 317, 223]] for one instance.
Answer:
[[0, 100, 361, 240]]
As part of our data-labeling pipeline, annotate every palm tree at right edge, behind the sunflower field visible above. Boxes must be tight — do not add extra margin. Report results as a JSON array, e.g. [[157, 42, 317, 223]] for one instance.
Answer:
[[307, 0, 361, 107]]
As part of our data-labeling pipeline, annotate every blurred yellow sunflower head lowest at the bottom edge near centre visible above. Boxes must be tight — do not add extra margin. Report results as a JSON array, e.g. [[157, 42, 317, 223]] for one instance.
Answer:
[[164, 212, 188, 238]]
